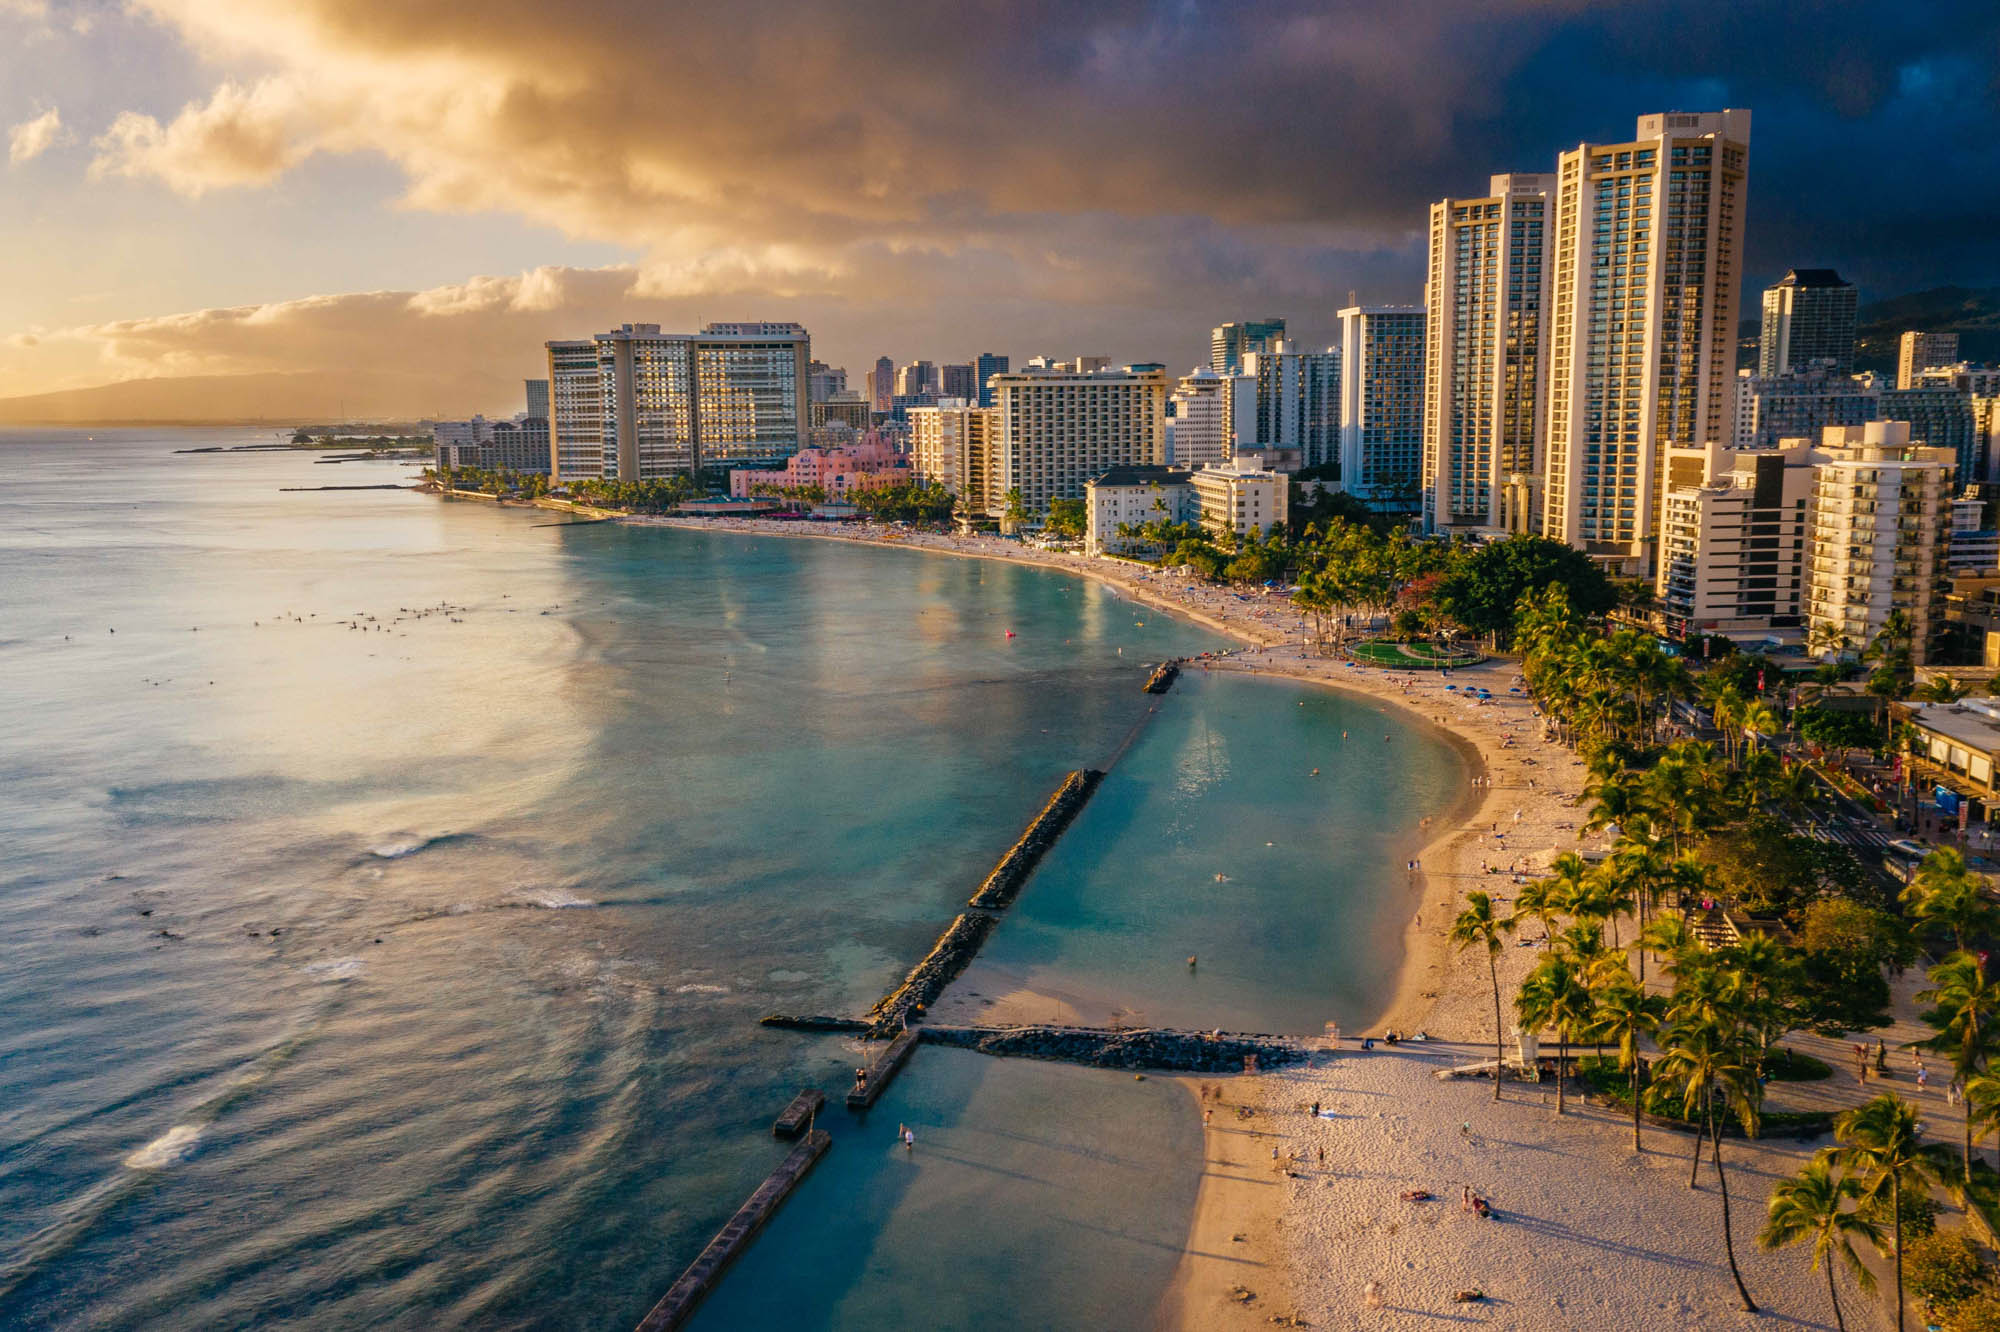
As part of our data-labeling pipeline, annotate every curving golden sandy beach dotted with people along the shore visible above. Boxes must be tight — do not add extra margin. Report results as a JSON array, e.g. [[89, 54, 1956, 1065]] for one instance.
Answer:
[[642, 520, 1890, 1332]]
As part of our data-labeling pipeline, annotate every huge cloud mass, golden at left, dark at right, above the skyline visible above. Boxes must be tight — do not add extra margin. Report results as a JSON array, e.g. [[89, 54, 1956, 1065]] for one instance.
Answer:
[[19, 0, 2000, 394]]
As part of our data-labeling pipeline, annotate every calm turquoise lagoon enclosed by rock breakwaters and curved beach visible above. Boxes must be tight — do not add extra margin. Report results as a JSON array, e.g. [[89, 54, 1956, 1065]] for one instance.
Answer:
[[980, 668, 1466, 1034]]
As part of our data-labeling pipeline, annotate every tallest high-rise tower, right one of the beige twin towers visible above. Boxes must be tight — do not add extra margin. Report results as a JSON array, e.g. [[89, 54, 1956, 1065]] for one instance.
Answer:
[[1542, 110, 1750, 570]]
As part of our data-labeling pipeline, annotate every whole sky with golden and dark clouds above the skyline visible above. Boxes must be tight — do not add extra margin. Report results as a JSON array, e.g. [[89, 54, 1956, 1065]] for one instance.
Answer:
[[0, 0, 2000, 416]]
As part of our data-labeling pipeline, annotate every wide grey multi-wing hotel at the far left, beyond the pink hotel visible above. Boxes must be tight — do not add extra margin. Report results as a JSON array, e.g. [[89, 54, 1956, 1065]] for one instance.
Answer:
[[546, 324, 812, 482]]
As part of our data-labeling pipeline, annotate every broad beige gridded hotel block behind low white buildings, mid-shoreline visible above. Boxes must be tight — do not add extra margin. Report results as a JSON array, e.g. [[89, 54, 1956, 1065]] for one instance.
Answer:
[[986, 358, 1166, 518]]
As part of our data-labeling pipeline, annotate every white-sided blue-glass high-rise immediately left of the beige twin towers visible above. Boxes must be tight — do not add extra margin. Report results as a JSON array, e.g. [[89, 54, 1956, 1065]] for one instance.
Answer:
[[1340, 306, 1424, 500]]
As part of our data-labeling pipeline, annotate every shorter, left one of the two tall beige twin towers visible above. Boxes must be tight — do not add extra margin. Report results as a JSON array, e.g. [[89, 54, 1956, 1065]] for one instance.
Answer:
[[1424, 174, 1556, 532]]
